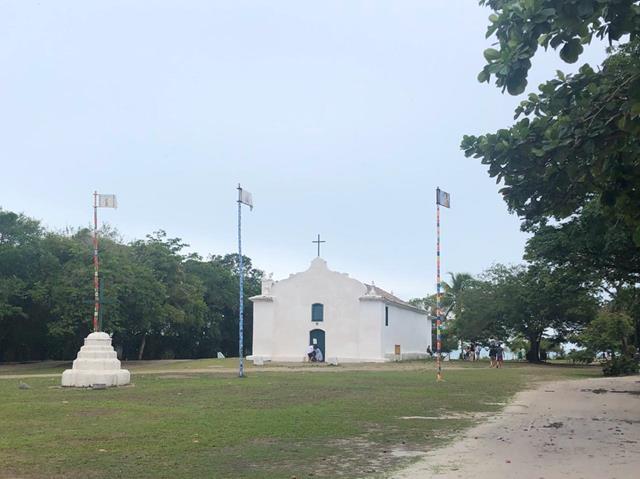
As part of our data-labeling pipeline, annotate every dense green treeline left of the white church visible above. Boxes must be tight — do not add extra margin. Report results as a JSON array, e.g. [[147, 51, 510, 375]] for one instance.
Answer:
[[0, 209, 262, 361]]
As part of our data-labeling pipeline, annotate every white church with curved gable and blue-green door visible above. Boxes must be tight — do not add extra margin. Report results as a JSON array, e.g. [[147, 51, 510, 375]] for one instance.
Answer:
[[249, 257, 431, 362]]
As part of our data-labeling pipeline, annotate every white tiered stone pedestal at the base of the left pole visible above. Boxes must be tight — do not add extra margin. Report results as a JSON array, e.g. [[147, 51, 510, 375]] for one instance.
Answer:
[[62, 332, 130, 387]]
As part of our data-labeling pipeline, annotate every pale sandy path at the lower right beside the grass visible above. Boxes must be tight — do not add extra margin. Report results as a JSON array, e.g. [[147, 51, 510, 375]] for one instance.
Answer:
[[390, 376, 640, 479]]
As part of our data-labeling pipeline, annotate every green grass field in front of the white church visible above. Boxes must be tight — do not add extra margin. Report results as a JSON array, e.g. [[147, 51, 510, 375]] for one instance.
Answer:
[[0, 360, 601, 479]]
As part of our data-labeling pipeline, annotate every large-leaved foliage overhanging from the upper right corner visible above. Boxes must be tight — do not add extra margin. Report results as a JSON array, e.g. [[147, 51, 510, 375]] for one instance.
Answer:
[[462, 0, 640, 244]]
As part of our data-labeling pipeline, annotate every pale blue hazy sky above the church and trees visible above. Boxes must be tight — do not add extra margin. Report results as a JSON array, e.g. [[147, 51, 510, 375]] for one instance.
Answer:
[[0, 0, 605, 299]]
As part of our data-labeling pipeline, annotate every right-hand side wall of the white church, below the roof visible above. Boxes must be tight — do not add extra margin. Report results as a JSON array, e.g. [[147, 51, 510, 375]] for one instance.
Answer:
[[382, 303, 431, 359]]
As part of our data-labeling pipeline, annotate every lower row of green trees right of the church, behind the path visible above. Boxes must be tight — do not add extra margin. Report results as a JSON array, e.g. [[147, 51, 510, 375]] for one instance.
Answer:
[[412, 260, 640, 362]]
